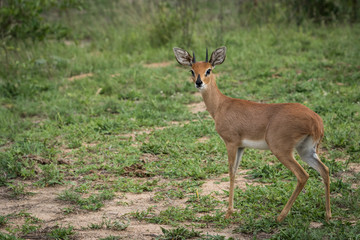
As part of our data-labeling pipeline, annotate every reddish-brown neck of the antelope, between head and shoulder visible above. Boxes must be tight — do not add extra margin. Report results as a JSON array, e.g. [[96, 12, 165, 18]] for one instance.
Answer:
[[201, 77, 226, 119]]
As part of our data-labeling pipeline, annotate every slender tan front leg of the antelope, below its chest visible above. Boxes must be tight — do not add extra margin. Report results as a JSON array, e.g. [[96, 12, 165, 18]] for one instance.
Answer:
[[225, 145, 244, 218]]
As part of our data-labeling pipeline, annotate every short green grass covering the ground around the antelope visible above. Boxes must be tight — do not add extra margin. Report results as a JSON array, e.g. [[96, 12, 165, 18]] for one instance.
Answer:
[[0, 2, 360, 239]]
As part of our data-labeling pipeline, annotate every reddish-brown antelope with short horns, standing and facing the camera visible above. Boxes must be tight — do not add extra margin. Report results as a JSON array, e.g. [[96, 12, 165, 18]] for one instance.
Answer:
[[173, 47, 331, 222]]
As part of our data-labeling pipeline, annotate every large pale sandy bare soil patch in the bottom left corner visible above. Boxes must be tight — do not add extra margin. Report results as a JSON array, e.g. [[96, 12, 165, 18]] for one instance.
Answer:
[[0, 186, 172, 239]]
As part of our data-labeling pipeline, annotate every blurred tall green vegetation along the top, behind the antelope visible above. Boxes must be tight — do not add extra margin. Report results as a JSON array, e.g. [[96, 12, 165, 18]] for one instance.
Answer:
[[0, 0, 359, 47]]
